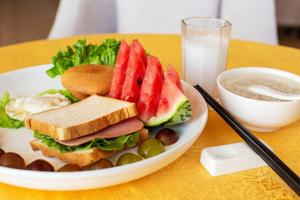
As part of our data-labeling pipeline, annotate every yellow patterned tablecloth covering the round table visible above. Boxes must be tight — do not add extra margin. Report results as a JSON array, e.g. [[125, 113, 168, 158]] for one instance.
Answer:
[[0, 34, 300, 200]]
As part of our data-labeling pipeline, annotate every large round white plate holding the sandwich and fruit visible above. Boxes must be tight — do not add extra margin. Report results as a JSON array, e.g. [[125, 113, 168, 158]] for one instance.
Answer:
[[0, 65, 207, 190]]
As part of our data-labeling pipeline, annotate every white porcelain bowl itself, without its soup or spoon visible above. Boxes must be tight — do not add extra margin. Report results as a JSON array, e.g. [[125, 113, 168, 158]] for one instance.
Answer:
[[217, 67, 300, 132]]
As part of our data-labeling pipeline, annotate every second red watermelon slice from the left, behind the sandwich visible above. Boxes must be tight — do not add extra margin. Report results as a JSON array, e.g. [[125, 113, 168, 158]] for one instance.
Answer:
[[121, 46, 145, 103]]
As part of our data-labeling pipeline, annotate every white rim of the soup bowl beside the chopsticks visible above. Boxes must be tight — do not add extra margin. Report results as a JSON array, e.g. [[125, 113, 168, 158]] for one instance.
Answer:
[[216, 66, 300, 105]]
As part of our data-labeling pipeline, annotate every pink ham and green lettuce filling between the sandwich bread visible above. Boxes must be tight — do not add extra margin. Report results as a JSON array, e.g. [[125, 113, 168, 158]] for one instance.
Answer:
[[34, 118, 143, 153]]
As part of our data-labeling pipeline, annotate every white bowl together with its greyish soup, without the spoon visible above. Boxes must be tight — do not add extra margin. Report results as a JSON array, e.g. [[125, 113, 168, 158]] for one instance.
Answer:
[[217, 67, 300, 132]]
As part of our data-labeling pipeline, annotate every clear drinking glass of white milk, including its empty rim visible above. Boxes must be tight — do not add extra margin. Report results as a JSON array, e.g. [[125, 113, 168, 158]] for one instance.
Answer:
[[181, 17, 231, 99]]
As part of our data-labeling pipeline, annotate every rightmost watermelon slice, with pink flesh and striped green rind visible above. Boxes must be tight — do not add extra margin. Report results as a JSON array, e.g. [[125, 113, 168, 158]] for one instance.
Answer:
[[145, 66, 192, 126]]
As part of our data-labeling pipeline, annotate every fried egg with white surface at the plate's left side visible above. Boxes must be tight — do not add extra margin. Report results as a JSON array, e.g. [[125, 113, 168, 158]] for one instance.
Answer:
[[5, 93, 71, 121]]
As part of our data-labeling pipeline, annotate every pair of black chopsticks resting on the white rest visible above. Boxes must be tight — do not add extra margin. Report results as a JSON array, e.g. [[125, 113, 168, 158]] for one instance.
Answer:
[[194, 85, 300, 195]]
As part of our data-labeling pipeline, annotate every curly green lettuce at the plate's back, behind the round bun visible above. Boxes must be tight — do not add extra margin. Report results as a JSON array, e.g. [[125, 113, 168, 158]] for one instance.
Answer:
[[47, 39, 120, 78]]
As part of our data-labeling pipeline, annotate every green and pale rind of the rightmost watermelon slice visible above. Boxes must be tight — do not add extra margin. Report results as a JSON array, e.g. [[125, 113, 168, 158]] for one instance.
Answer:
[[145, 95, 192, 126]]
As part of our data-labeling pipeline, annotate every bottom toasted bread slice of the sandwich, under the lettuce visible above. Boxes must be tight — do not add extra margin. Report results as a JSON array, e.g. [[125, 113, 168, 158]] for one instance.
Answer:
[[30, 140, 114, 167]]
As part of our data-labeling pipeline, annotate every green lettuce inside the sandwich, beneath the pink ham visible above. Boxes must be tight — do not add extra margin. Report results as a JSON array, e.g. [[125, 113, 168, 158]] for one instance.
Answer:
[[34, 131, 139, 153]]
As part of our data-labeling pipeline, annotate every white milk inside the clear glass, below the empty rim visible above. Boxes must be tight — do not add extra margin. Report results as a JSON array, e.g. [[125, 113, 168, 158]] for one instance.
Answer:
[[183, 35, 229, 98]]
